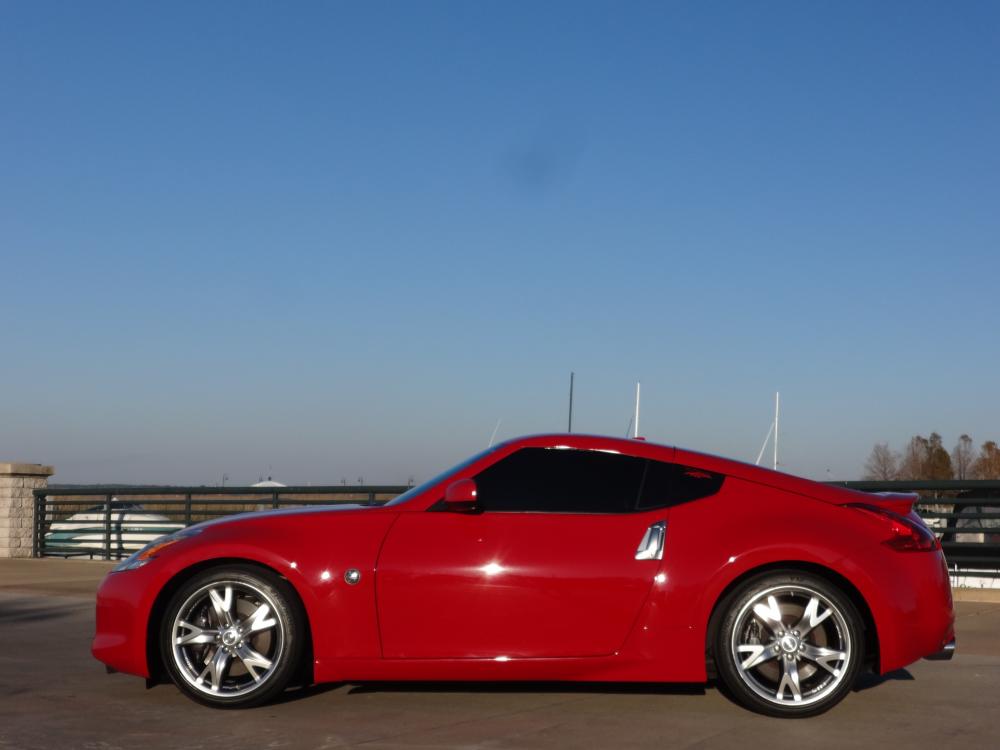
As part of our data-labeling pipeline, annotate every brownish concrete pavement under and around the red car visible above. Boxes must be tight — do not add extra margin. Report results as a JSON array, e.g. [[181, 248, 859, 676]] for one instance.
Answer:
[[0, 560, 1000, 750]]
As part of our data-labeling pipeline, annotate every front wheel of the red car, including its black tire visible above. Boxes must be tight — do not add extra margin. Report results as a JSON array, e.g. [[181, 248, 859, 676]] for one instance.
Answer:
[[159, 564, 306, 708]]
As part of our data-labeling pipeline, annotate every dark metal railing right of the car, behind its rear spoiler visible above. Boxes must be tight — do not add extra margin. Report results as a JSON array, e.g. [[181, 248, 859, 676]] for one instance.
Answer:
[[836, 479, 1000, 583]]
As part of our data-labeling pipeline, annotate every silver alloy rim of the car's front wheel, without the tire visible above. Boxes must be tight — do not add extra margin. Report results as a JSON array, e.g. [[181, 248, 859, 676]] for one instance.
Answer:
[[170, 580, 288, 698]]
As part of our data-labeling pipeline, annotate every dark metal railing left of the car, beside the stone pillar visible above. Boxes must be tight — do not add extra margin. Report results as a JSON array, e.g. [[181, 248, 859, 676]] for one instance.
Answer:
[[32, 485, 408, 560]]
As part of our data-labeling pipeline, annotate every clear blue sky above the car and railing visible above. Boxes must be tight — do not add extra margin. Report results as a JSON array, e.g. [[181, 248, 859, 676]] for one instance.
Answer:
[[0, 1, 1000, 484]]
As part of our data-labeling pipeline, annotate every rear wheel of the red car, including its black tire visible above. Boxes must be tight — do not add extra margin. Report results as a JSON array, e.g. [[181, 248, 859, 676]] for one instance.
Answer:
[[712, 570, 865, 718]]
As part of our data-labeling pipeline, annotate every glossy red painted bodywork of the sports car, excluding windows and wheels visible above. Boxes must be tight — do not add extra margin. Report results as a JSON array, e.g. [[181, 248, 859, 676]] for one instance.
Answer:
[[93, 435, 954, 682]]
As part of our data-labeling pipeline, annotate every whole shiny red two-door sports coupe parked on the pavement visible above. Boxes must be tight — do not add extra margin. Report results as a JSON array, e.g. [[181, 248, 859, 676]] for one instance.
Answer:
[[93, 434, 955, 716]]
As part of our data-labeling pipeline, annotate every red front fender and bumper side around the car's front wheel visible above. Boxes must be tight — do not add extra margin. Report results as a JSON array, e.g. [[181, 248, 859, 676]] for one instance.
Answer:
[[92, 508, 397, 679]]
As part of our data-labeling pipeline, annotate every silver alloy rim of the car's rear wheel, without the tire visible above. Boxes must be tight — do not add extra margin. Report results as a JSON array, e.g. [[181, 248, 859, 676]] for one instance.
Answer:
[[730, 584, 852, 706]]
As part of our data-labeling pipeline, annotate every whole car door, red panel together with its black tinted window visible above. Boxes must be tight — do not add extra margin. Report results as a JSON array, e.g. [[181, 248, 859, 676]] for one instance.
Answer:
[[377, 448, 666, 659]]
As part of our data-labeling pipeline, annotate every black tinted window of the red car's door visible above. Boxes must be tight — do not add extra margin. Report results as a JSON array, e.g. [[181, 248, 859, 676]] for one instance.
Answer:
[[476, 448, 646, 513]]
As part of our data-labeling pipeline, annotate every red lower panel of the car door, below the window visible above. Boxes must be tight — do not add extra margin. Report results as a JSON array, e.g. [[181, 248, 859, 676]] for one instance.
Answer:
[[378, 510, 665, 659]]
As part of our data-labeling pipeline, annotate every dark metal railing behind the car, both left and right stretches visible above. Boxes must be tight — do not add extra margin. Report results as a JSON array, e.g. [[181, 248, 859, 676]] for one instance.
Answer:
[[33, 480, 1000, 578]]
